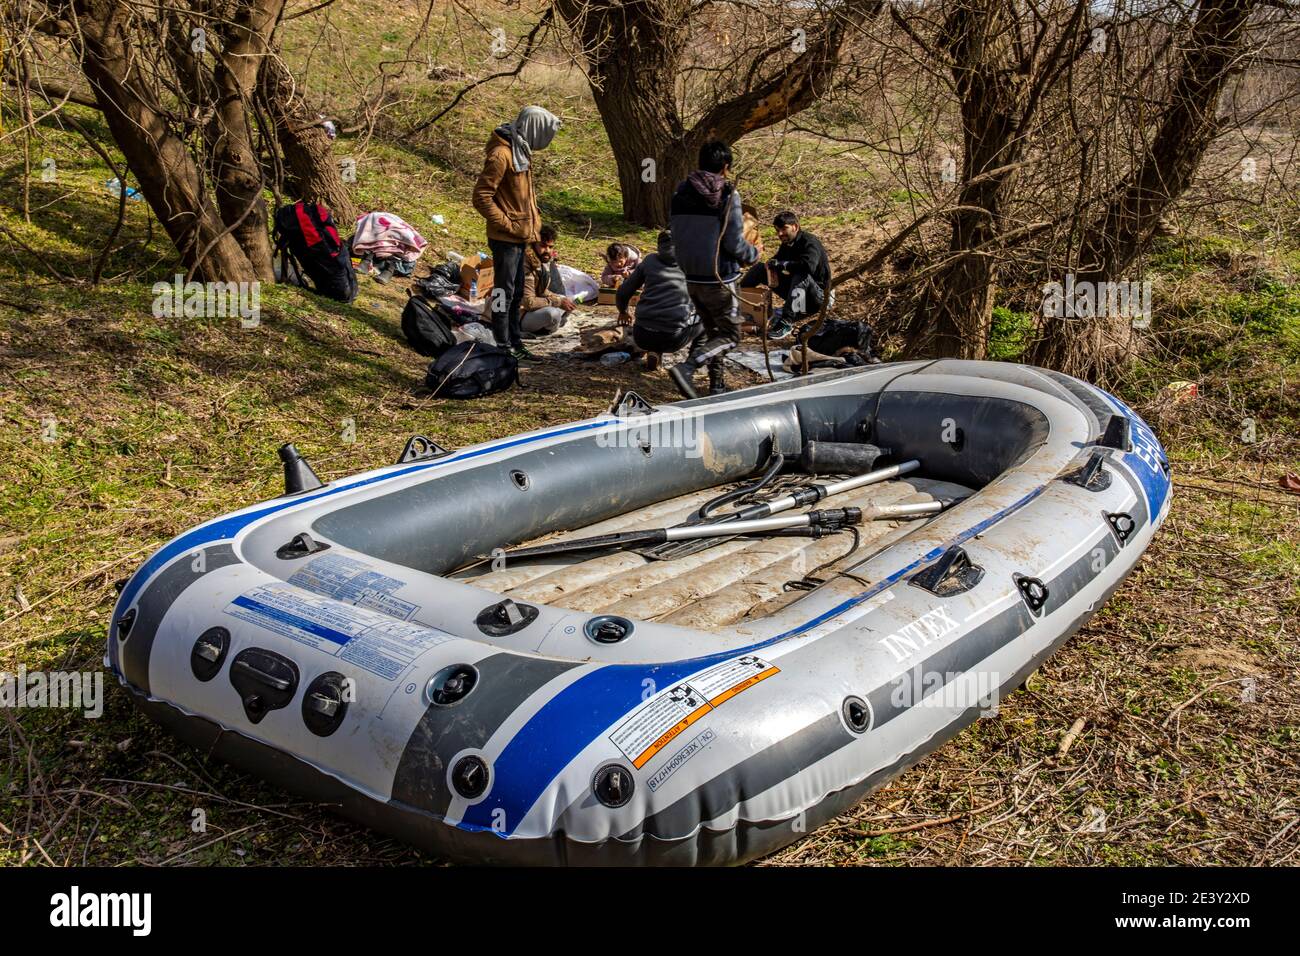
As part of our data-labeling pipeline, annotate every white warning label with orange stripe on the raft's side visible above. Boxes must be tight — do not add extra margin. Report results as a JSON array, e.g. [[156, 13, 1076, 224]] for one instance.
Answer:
[[610, 656, 780, 770]]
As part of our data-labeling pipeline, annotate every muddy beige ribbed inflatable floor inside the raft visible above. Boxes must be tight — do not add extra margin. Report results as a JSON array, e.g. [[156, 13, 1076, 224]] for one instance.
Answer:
[[454, 477, 972, 631]]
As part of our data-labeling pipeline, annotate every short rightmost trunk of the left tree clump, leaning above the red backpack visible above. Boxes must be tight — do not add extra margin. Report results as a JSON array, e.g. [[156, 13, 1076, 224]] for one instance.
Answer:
[[260, 52, 356, 229]]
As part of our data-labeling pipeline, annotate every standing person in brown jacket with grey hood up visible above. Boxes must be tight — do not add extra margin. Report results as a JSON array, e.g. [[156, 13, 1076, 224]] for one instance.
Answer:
[[475, 107, 560, 359]]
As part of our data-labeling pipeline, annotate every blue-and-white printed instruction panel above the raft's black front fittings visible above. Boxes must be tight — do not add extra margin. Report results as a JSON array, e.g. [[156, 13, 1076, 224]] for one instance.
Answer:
[[226, 584, 455, 680]]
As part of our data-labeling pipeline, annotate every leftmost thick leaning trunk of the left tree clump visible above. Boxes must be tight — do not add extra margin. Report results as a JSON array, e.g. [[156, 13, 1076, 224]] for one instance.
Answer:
[[78, 0, 259, 282]]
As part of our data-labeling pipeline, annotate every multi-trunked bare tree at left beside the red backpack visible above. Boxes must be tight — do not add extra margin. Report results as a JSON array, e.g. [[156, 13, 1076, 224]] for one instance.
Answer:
[[5, 0, 347, 281]]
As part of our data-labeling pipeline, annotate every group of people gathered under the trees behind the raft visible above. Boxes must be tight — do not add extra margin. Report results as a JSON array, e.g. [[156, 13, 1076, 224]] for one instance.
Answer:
[[475, 100, 831, 398]]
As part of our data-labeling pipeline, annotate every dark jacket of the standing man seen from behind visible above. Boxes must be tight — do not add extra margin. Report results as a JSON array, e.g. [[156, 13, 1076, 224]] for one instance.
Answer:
[[670, 170, 758, 285]]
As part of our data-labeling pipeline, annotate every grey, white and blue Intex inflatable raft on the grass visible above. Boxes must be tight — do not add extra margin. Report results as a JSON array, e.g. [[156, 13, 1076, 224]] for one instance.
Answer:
[[107, 360, 1170, 864]]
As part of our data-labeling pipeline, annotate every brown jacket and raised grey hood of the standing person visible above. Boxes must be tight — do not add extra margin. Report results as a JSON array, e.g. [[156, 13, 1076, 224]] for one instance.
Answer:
[[473, 107, 560, 242]]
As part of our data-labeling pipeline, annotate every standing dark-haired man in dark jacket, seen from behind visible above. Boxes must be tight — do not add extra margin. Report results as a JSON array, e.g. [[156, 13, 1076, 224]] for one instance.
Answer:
[[668, 139, 759, 398]]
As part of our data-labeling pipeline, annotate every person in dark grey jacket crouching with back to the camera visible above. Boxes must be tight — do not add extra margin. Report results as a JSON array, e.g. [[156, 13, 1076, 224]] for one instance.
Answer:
[[614, 230, 703, 372]]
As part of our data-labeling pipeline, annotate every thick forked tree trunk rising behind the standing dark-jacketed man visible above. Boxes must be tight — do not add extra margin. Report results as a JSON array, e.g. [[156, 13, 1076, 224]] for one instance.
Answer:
[[555, 0, 883, 225]]
